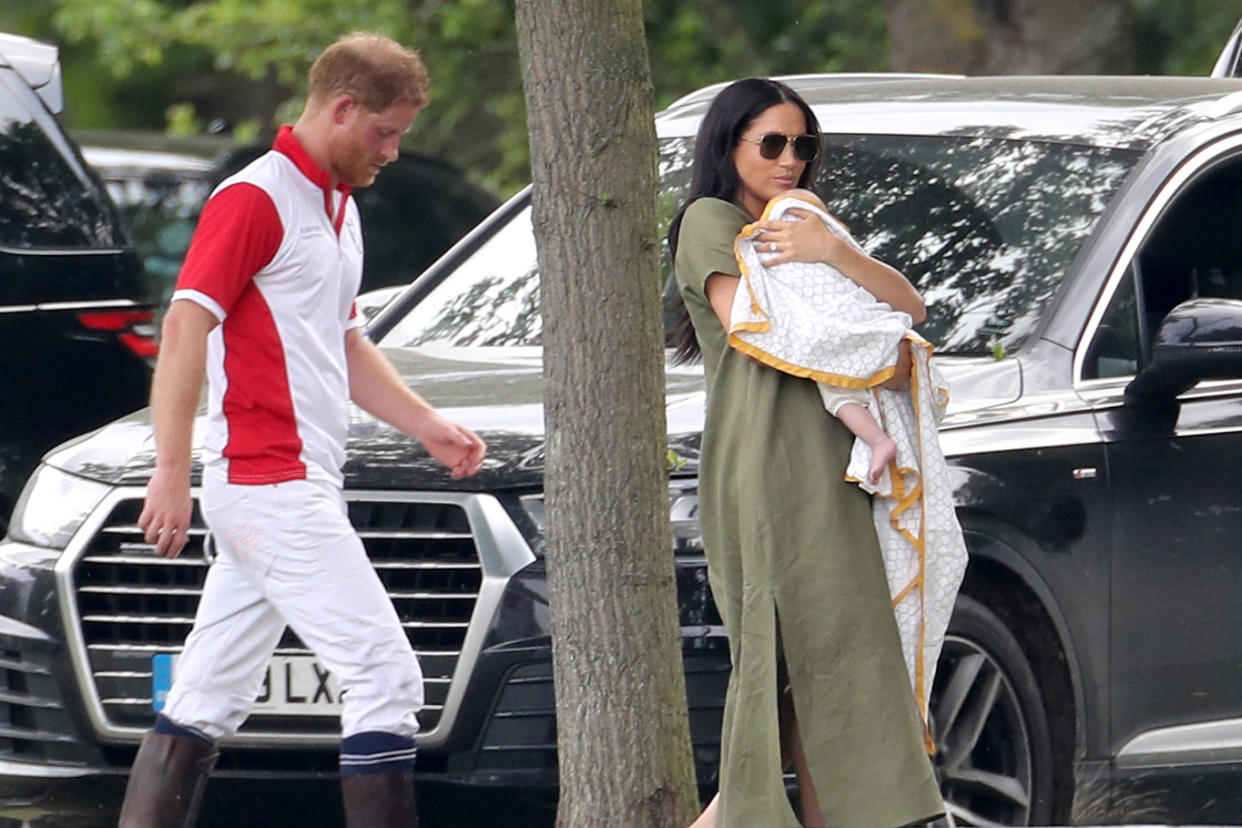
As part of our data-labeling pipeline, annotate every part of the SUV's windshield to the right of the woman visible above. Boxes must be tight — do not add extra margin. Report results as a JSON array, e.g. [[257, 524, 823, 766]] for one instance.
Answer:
[[817, 135, 1139, 354]]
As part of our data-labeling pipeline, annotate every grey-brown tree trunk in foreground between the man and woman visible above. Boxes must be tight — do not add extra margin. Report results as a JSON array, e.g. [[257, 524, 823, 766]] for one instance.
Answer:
[[506, 0, 698, 828]]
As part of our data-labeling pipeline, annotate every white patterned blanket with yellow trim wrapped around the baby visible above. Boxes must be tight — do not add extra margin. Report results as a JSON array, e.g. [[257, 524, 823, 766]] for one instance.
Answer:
[[729, 196, 966, 720]]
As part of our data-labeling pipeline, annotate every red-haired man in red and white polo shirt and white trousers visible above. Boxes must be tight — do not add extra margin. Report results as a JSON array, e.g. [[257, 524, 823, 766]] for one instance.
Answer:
[[120, 34, 486, 828]]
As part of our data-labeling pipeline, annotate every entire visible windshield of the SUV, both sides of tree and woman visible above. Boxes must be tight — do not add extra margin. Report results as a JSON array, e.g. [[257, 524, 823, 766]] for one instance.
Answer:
[[383, 135, 1138, 355]]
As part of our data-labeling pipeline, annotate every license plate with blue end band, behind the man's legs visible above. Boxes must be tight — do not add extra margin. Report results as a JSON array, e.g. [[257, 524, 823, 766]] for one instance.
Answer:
[[152, 653, 342, 716]]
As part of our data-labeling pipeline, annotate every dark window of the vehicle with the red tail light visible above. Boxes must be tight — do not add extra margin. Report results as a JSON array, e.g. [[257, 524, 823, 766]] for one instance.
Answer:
[[0, 72, 122, 248]]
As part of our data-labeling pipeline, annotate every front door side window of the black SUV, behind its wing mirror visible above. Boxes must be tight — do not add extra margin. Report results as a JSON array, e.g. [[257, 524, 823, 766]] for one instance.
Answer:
[[1083, 150, 1242, 379]]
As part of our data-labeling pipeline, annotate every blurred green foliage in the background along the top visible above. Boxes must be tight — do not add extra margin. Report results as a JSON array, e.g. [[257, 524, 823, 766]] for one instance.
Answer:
[[0, 0, 1242, 195]]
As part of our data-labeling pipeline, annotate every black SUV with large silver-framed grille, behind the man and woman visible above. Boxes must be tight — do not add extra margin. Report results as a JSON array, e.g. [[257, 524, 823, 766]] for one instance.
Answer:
[[0, 76, 1242, 824]]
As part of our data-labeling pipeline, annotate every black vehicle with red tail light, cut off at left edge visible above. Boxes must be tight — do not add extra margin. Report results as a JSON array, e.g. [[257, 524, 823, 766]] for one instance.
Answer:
[[0, 34, 155, 528]]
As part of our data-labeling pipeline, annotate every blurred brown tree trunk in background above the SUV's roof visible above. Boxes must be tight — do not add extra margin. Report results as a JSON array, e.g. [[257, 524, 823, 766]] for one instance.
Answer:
[[887, 0, 1134, 74]]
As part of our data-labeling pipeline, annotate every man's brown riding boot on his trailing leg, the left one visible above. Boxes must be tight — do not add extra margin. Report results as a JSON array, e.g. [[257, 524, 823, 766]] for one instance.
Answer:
[[118, 731, 220, 828]]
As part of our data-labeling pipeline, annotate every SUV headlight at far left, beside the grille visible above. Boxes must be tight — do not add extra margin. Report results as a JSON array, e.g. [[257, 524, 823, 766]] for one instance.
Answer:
[[9, 466, 112, 549]]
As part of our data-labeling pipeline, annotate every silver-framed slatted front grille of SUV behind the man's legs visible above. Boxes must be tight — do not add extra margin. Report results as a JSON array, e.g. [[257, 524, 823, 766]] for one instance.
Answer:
[[60, 489, 533, 744]]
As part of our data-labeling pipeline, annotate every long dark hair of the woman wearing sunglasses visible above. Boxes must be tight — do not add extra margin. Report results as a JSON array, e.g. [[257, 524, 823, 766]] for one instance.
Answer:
[[666, 78, 820, 362]]
